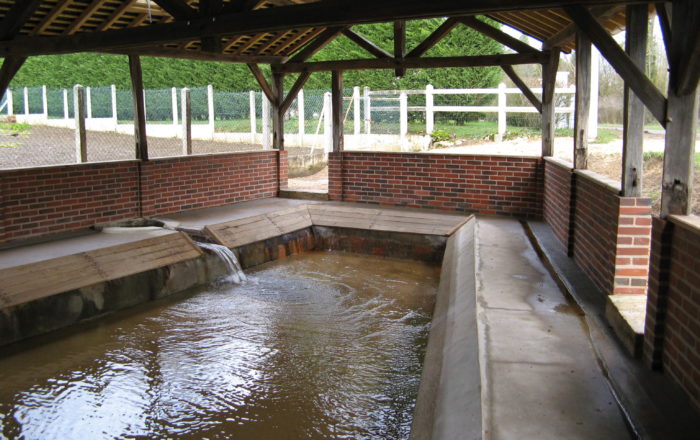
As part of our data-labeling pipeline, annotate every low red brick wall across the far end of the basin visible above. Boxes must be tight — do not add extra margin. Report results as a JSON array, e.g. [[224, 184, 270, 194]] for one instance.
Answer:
[[328, 151, 543, 218]]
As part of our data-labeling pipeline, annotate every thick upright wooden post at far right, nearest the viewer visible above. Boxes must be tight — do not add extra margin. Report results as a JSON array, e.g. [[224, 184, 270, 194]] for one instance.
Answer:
[[661, 0, 700, 218]]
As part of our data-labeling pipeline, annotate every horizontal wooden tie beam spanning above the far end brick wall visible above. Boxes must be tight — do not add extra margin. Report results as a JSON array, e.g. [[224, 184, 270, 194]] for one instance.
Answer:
[[279, 52, 549, 73]]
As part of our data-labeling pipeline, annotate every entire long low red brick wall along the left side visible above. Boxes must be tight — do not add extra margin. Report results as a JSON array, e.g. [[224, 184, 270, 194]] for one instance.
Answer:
[[0, 151, 287, 243]]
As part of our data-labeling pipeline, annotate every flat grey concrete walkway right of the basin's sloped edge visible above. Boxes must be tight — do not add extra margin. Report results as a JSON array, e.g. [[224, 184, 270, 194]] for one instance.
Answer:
[[476, 218, 630, 440]]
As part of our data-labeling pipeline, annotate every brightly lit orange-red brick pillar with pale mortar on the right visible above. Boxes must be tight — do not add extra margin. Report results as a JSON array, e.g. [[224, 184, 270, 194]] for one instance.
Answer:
[[612, 197, 651, 295]]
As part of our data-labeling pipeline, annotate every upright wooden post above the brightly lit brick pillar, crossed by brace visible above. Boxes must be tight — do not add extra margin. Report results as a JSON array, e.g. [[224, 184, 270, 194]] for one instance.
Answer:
[[622, 5, 649, 197]]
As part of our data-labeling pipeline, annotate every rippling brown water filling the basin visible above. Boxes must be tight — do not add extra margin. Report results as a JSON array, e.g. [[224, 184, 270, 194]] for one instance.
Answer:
[[0, 252, 438, 440]]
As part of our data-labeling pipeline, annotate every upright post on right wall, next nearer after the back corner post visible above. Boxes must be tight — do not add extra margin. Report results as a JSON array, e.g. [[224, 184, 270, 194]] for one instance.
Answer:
[[574, 32, 593, 170]]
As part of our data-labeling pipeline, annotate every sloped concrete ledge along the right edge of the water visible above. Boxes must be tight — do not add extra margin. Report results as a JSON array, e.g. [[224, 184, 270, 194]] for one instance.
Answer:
[[410, 216, 482, 440]]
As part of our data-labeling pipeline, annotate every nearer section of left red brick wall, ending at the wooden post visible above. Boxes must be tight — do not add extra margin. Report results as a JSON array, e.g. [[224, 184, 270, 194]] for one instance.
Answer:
[[0, 161, 138, 242]]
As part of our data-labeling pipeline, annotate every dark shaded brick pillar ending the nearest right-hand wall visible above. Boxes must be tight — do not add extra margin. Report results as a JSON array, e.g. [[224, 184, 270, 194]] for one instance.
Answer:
[[644, 217, 673, 370]]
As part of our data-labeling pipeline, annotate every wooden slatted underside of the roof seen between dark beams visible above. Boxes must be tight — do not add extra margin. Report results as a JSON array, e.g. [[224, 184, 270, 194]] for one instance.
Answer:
[[0, 0, 636, 61]]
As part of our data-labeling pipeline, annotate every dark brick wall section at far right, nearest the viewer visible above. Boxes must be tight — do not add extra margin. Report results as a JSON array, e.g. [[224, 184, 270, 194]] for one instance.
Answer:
[[644, 216, 700, 410]]
